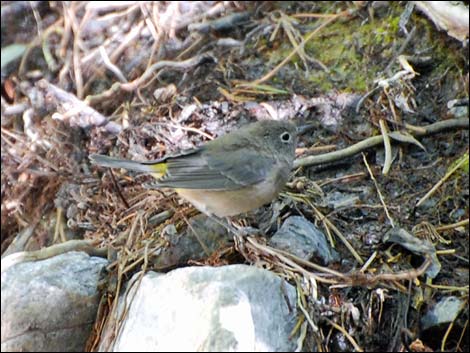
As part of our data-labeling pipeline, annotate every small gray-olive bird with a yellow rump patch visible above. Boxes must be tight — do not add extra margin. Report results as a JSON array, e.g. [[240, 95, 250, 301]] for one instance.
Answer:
[[89, 120, 297, 218]]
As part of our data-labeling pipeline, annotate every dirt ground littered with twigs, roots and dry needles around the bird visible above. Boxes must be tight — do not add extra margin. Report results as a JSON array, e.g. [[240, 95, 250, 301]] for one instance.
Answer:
[[1, 1, 469, 351]]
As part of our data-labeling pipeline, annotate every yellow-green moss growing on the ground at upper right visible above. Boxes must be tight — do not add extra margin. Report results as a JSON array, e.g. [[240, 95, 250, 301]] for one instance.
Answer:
[[252, 3, 463, 97]]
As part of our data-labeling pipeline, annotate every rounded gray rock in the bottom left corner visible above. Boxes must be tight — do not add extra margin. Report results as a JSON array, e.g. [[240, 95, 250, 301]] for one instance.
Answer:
[[1, 252, 107, 352]]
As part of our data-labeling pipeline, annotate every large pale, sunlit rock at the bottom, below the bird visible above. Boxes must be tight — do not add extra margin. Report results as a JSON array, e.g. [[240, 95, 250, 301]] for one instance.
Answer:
[[106, 265, 297, 352]]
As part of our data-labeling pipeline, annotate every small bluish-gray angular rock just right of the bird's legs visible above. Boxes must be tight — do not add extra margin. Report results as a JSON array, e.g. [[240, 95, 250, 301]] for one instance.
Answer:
[[269, 216, 339, 265]]
